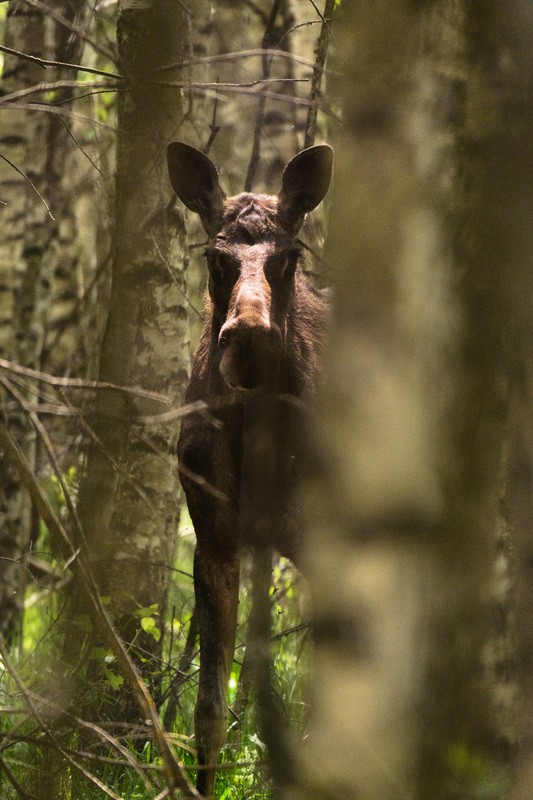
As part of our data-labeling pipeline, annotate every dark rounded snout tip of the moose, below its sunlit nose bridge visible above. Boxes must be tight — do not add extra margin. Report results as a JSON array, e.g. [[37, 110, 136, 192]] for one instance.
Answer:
[[218, 317, 283, 390]]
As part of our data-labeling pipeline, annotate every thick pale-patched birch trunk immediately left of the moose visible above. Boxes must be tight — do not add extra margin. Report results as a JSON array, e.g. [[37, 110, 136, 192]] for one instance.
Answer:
[[69, 0, 188, 718]]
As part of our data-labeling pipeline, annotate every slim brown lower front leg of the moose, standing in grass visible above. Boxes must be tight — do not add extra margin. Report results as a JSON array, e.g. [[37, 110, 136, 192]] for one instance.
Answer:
[[194, 542, 239, 797]]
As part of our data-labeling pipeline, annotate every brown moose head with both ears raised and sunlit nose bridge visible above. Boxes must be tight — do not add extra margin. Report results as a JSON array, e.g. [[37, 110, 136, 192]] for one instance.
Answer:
[[167, 142, 333, 390]]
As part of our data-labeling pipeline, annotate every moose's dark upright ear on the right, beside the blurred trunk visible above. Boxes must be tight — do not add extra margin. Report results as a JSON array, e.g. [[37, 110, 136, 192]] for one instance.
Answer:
[[278, 144, 333, 234]]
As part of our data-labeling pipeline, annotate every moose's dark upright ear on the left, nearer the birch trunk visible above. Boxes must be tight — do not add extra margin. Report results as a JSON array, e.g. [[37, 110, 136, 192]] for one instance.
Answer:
[[167, 142, 226, 235]]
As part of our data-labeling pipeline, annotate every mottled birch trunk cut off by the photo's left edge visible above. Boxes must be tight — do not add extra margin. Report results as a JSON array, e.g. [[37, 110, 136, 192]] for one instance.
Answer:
[[0, 3, 46, 640]]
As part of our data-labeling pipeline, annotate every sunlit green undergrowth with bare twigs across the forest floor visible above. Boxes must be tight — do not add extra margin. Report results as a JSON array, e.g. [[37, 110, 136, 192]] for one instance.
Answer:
[[0, 506, 309, 800]]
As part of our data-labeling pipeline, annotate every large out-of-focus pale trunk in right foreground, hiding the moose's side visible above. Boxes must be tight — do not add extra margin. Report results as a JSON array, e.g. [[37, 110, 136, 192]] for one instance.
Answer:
[[301, 0, 531, 800]]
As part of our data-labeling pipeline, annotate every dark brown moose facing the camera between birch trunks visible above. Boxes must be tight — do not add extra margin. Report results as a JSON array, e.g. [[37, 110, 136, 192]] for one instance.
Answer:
[[167, 142, 333, 796]]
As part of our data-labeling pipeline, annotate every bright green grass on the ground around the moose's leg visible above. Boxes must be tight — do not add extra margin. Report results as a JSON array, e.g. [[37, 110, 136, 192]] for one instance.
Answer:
[[0, 506, 309, 800]]
